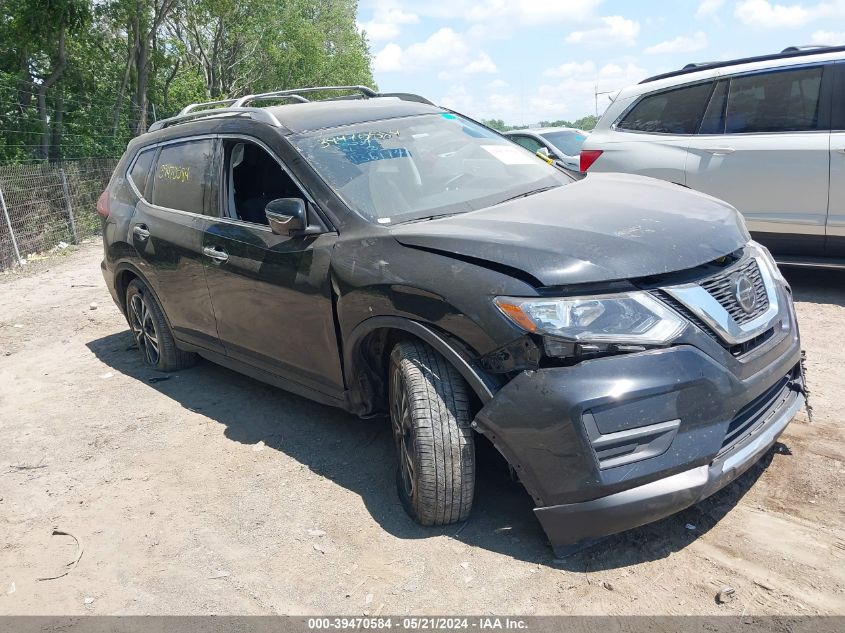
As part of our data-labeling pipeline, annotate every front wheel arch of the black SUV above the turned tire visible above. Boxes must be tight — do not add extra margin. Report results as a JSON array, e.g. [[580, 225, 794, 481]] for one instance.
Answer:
[[343, 316, 497, 415]]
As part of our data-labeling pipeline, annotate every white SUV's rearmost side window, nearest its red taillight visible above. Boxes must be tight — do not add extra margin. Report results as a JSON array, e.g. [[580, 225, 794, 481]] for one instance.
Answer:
[[616, 83, 713, 134]]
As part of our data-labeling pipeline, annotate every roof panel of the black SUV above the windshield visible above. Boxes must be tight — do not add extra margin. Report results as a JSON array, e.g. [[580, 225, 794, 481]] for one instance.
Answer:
[[267, 97, 444, 133]]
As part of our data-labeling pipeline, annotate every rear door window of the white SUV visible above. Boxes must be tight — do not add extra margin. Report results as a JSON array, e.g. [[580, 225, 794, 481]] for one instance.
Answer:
[[725, 68, 822, 134]]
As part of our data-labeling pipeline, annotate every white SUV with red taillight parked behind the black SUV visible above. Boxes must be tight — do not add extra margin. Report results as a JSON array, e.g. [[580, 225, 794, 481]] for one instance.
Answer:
[[581, 47, 845, 266]]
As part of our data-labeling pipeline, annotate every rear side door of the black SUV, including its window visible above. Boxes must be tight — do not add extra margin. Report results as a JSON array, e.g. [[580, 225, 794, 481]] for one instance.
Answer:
[[130, 138, 223, 352]]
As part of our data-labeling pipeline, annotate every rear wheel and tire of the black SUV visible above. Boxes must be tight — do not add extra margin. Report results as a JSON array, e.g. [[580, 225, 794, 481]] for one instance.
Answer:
[[126, 279, 197, 371]]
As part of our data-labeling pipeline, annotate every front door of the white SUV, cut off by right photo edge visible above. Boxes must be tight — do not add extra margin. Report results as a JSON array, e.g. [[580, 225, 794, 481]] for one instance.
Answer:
[[825, 60, 845, 257]]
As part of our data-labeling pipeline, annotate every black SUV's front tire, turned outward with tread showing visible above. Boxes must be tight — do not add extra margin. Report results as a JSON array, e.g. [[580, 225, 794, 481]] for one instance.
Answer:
[[389, 341, 475, 525]]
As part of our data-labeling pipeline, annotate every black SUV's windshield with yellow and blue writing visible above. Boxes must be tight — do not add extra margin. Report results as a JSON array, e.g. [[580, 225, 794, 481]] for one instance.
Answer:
[[292, 113, 571, 224]]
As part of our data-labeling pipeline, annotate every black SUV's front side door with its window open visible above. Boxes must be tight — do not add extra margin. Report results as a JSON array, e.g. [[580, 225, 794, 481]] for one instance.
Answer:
[[203, 138, 343, 398]]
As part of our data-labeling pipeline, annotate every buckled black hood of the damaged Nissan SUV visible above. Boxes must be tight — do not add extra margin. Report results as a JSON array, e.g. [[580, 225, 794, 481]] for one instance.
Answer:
[[391, 174, 749, 286]]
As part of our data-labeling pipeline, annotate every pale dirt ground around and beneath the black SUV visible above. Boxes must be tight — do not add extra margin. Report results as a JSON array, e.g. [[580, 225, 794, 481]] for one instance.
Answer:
[[0, 243, 845, 615]]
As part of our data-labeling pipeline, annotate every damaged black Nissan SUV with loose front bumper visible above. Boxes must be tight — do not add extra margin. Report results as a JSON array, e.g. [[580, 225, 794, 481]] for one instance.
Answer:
[[98, 87, 804, 551]]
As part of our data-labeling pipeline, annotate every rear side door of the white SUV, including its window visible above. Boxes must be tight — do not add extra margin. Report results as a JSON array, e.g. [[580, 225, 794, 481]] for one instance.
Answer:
[[686, 65, 831, 255]]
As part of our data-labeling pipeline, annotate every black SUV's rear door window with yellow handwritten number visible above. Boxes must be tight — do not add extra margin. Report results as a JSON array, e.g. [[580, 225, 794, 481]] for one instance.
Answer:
[[153, 139, 217, 215]]
